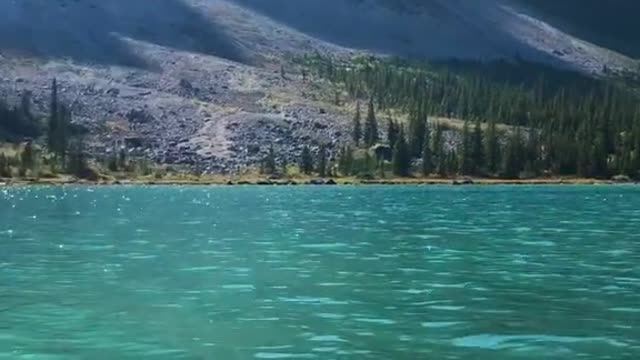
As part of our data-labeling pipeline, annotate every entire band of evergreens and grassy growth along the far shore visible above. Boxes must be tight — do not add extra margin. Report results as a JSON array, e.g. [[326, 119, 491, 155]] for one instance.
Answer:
[[0, 54, 640, 187]]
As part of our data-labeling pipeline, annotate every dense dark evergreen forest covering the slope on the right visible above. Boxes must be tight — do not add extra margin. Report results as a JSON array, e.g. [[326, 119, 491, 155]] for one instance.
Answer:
[[301, 54, 640, 178]]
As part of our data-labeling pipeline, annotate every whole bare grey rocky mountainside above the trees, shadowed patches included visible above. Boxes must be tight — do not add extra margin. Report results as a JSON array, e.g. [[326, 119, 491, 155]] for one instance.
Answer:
[[0, 0, 634, 171]]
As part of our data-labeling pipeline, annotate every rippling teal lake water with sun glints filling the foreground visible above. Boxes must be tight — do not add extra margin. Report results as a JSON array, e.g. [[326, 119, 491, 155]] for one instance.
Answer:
[[0, 186, 640, 360]]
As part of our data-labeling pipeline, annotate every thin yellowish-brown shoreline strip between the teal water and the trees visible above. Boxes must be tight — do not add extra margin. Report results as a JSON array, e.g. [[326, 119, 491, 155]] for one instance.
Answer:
[[0, 177, 640, 187]]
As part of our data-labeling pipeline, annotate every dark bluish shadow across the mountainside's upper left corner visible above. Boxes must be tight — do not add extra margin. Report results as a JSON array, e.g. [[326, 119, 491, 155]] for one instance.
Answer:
[[0, 0, 245, 68]]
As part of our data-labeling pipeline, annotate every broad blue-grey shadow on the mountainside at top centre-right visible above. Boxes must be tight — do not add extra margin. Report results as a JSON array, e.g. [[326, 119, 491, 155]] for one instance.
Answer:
[[230, 0, 552, 61]]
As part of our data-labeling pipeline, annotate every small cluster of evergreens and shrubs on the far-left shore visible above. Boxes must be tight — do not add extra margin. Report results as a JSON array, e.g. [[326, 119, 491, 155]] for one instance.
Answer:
[[0, 79, 176, 183]]
